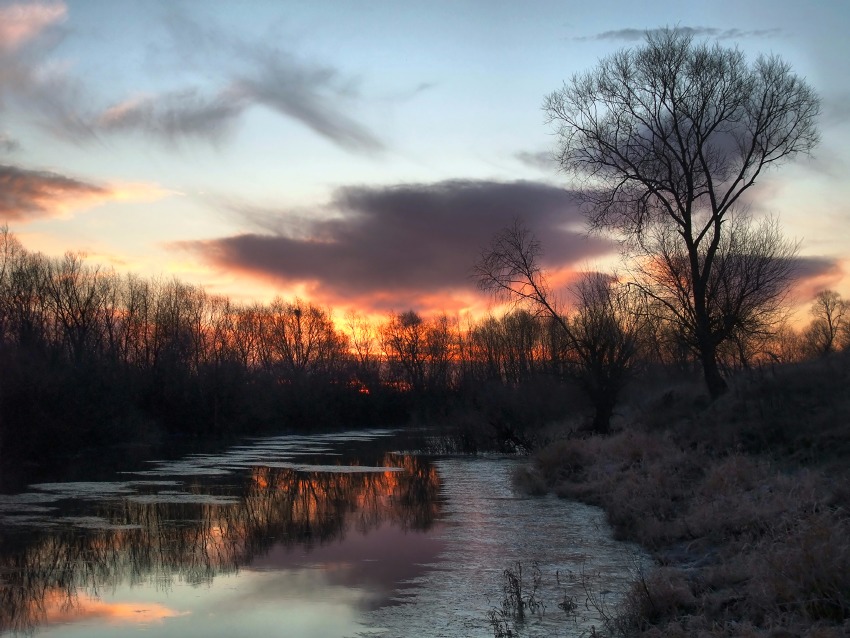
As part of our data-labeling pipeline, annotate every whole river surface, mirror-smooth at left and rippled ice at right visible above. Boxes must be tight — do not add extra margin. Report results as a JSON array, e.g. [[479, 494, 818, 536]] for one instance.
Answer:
[[0, 430, 637, 638]]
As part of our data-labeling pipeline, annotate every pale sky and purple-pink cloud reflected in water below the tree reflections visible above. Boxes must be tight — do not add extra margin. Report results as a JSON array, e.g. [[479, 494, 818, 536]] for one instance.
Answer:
[[32, 524, 443, 638]]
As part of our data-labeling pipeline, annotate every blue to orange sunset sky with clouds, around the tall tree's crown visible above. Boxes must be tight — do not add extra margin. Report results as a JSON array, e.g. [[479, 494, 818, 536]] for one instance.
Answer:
[[0, 0, 850, 314]]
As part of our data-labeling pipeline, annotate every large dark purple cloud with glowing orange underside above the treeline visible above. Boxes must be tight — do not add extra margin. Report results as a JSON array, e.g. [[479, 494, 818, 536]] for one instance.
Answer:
[[180, 181, 613, 310]]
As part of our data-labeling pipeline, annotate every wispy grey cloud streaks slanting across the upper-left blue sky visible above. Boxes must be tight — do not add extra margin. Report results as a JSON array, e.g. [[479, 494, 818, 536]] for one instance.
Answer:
[[86, 12, 383, 153]]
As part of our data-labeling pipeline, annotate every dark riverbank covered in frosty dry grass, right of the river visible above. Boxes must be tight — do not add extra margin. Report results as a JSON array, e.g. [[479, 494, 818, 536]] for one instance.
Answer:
[[516, 353, 850, 638]]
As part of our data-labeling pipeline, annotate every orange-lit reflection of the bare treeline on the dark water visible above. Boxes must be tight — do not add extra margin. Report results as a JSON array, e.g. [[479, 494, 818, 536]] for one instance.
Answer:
[[0, 454, 440, 632]]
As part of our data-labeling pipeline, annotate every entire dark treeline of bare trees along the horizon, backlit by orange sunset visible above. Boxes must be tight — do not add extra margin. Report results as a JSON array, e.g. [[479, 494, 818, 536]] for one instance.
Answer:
[[0, 229, 848, 466]]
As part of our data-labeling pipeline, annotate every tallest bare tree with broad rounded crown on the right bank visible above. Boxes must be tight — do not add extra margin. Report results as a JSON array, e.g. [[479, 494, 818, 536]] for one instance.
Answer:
[[544, 29, 820, 397]]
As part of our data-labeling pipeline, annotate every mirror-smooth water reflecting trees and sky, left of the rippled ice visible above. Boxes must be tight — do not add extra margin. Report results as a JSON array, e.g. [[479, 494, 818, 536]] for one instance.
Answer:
[[0, 430, 442, 637]]
